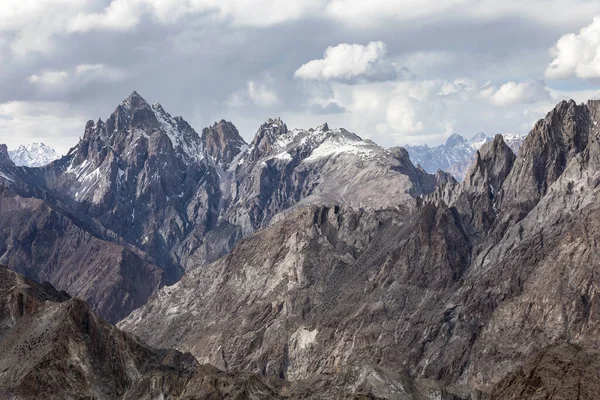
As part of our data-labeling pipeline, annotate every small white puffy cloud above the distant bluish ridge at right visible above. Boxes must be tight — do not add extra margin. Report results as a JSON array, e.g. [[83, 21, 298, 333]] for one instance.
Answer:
[[481, 80, 550, 107]]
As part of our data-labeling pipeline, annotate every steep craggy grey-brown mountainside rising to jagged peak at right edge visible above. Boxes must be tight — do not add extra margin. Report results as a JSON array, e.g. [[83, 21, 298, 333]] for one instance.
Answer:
[[418, 102, 600, 390]]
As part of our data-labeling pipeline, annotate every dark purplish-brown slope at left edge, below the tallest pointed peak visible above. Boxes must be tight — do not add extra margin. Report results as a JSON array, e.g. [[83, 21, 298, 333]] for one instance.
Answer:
[[0, 188, 164, 321]]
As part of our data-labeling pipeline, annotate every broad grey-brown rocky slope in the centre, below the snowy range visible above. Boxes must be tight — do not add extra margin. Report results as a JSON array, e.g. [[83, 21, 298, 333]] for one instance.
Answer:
[[120, 206, 476, 390]]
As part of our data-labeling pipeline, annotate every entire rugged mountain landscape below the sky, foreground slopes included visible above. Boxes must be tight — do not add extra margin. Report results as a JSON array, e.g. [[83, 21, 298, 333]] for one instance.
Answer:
[[0, 92, 600, 400]]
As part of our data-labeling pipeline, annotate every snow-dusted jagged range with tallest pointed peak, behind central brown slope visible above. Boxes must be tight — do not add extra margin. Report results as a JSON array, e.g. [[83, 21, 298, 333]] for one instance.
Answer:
[[0, 92, 436, 322]]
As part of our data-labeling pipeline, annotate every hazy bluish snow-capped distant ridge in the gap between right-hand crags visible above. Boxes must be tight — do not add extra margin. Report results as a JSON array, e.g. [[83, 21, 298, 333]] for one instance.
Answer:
[[405, 132, 525, 181]]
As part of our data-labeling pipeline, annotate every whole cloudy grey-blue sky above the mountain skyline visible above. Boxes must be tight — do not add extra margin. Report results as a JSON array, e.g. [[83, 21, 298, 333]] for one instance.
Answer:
[[0, 0, 600, 152]]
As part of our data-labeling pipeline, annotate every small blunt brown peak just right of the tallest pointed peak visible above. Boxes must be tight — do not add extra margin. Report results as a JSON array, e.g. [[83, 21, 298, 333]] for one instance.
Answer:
[[201, 120, 247, 169]]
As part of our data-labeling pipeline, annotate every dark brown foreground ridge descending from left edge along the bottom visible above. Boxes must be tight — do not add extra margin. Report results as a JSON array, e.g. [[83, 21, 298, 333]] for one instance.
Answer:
[[0, 266, 451, 400]]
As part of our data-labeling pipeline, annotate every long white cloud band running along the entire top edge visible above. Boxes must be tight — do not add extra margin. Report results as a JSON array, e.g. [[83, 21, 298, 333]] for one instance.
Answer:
[[0, 0, 600, 57]]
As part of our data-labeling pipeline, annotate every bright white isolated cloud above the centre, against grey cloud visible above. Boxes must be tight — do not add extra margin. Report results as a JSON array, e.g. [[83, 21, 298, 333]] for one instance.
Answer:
[[294, 41, 386, 80]]
